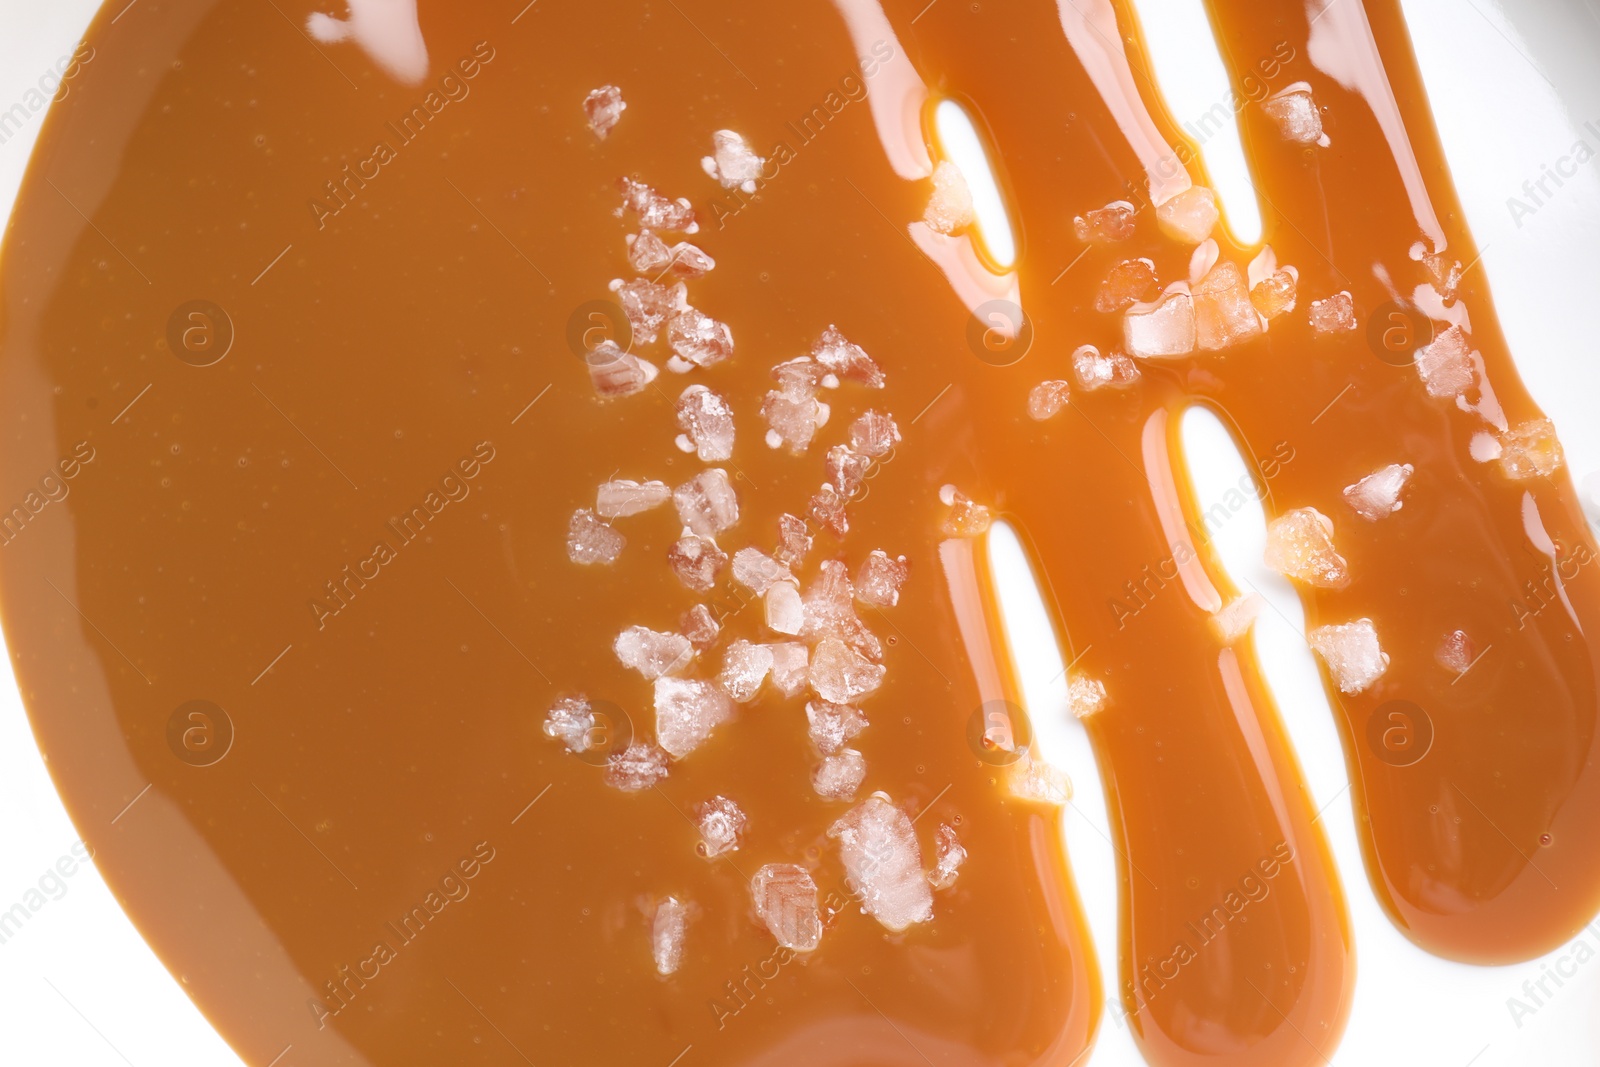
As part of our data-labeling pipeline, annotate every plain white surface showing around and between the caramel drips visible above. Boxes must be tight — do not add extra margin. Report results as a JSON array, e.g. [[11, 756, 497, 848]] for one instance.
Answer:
[[0, 0, 1600, 1067]]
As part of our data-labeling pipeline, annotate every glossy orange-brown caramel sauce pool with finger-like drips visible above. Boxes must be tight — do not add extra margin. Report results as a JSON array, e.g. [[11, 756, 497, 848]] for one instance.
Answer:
[[0, 0, 1600, 1065]]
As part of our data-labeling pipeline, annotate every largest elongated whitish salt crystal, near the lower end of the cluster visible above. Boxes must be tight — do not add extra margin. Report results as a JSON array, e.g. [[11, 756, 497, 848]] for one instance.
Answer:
[[827, 793, 933, 933]]
